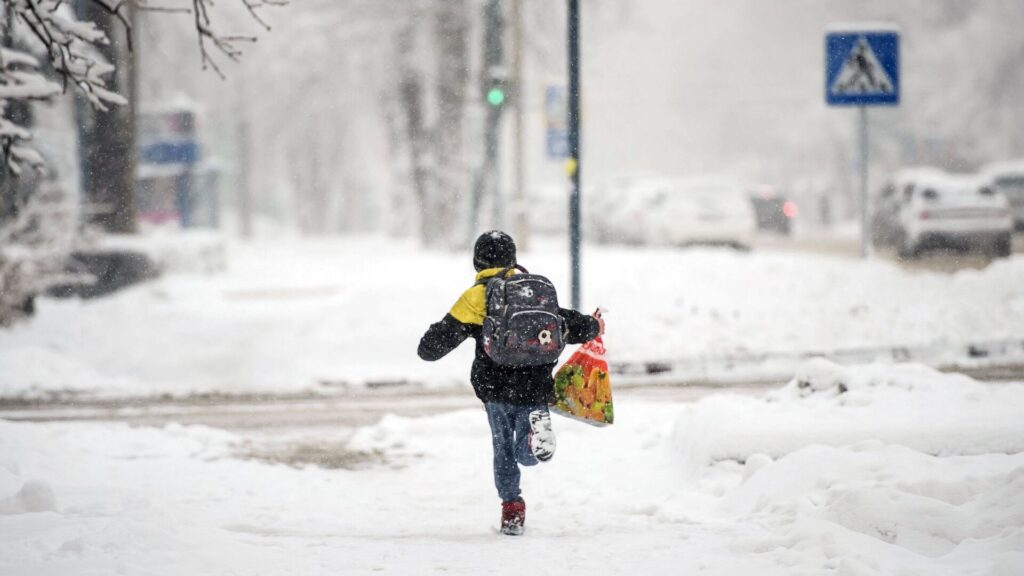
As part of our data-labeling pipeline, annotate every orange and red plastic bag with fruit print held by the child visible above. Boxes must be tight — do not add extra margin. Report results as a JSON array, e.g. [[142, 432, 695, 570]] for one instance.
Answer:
[[551, 338, 614, 426]]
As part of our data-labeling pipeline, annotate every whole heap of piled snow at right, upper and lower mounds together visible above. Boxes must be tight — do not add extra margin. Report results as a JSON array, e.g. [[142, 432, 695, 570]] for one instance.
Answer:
[[659, 360, 1024, 576]]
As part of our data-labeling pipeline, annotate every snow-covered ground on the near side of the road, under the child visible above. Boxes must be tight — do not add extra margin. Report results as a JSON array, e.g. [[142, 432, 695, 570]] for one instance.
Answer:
[[0, 361, 1024, 576]]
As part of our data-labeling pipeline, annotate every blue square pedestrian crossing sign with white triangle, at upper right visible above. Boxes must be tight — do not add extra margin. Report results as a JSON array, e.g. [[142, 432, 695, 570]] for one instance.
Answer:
[[825, 30, 899, 106]]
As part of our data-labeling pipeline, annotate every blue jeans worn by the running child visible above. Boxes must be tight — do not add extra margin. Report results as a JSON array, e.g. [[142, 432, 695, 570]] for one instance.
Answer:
[[483, 402, 548, 501]]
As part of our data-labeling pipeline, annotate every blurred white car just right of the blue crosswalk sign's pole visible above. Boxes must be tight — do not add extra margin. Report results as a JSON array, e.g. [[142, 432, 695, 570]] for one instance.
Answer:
[[873, 169, 1013, 257]]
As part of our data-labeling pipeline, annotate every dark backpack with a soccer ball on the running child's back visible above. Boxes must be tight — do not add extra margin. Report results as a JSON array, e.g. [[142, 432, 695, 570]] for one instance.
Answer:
[[478, 265, 565, 366]]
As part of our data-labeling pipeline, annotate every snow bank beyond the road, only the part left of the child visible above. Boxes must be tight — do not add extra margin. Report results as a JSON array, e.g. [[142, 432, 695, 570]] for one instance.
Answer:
[[0, 239, 472, 396]]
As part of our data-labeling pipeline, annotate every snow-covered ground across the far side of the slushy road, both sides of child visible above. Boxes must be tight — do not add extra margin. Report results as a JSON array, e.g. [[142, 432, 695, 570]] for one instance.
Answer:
[[0, 238, 1024, 396]]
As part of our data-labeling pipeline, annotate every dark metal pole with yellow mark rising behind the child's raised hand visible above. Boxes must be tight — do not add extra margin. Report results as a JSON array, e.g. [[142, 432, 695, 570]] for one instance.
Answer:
[[566, 0, 582, 310]]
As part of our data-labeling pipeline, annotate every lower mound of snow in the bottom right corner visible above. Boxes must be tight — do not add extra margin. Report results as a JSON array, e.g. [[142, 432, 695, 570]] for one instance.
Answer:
[[719, 442, 1024, 576]]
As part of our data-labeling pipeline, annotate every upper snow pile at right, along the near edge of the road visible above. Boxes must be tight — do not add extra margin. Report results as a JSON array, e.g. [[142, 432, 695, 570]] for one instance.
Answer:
[[675, 359, 1024, 465]]
